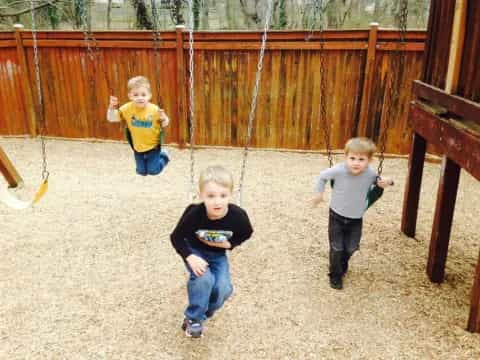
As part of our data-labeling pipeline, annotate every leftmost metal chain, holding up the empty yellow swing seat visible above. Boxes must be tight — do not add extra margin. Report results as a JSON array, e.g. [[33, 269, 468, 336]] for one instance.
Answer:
[[30, 0, 50, 181]]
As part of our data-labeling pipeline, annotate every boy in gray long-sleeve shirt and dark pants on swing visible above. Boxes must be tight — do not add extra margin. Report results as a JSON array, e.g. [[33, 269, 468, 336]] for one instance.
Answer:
[[312, 138, 393, 289]]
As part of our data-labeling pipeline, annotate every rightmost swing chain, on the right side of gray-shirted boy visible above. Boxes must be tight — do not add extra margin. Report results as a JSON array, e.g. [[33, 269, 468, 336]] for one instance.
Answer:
[[377, 0, 408, 176]]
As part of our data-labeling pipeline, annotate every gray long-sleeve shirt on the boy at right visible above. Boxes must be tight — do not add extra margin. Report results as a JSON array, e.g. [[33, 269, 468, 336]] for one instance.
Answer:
[[316, 163, 377, 219]]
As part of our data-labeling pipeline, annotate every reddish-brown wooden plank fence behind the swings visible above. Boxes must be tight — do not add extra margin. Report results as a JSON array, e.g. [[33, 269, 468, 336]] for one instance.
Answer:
[[0, 26, 425, 154]]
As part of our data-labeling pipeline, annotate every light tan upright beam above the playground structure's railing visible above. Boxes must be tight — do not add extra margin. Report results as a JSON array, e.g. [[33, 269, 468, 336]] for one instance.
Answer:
[[445, 0, 467, 94]]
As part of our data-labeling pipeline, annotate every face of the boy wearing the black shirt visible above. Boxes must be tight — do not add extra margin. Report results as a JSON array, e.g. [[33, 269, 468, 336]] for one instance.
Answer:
[[200, 181, 232, 220]]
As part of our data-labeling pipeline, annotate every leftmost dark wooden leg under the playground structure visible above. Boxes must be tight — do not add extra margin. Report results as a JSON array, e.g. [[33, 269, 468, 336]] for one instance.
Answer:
[[401, 131, 427, 237]]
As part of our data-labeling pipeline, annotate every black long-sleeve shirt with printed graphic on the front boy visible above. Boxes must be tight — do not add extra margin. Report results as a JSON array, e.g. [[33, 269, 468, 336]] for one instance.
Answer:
[[170, 203, 253, 259]]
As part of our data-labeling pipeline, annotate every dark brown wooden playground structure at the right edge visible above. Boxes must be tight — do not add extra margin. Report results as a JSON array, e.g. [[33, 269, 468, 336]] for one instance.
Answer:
[[402, 0, 480, 332]]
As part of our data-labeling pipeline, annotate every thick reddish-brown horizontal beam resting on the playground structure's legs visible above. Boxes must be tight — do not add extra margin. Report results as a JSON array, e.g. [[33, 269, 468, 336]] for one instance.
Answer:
[[410, 103, 480, 180]]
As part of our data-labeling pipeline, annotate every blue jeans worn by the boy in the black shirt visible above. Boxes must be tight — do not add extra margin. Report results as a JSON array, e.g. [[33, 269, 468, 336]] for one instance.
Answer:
[[185, 249, 233, 322]]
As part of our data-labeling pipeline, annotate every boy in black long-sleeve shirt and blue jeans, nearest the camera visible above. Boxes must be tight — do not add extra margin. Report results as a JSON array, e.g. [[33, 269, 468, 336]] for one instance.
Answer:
[[170, 166, 253, 337]]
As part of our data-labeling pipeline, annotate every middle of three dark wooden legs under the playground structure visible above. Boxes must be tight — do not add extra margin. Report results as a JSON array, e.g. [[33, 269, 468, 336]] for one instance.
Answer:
[[427, 156, 461, 283]]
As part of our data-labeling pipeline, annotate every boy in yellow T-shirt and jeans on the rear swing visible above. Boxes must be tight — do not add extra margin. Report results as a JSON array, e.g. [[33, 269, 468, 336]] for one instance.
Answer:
[[107, 76, 170, 176]]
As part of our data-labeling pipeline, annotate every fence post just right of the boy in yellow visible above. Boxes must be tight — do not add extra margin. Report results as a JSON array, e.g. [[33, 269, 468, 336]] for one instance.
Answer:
[[176, 25, 188, 148]]
